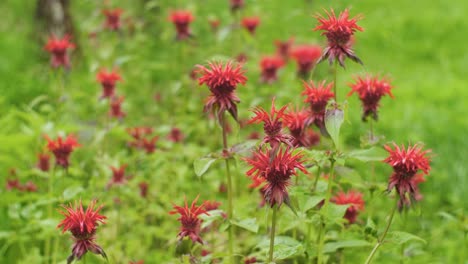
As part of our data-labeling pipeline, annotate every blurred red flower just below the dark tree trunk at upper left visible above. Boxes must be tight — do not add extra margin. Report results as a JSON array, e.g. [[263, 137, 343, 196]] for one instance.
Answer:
[[44, 35, 75, 69]]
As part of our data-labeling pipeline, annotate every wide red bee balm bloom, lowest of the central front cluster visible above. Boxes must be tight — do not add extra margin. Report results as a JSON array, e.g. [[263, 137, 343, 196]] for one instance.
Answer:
[[244, 147, 307, 207]]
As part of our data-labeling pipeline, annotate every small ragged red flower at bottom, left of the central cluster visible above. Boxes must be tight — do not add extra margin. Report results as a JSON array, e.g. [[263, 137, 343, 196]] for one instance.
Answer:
[[169, 196, 208, 244]]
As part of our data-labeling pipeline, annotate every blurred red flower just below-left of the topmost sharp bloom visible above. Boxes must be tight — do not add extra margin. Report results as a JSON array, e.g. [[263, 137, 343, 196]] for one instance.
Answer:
[[290, 45, 322, 78]]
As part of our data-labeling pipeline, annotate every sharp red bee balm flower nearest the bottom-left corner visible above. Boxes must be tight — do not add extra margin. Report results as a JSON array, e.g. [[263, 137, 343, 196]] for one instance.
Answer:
[[57, 200, 107, 263]]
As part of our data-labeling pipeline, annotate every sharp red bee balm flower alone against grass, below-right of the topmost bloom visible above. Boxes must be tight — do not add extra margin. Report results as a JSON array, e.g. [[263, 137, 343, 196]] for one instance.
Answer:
[[348, 75, 393, 121]]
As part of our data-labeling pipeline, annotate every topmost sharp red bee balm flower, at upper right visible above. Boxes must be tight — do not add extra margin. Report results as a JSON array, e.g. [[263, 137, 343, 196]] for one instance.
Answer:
[[314, 9, 363, 68]]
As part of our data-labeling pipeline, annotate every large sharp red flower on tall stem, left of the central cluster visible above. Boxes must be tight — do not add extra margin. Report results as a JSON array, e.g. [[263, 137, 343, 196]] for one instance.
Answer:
[[198, 61, 247, 120]]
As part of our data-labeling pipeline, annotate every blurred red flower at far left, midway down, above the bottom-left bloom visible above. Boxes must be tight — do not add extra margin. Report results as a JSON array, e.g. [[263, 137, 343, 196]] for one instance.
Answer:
[[46, 135, 80, 168]]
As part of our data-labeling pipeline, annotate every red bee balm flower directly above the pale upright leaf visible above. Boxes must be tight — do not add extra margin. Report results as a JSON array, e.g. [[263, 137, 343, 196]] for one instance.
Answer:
[[302, 81, 335, 128]]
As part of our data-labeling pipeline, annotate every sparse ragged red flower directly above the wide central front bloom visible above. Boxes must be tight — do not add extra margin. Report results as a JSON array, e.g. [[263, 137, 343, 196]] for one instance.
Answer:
[[249, 98, 293, 149]]
